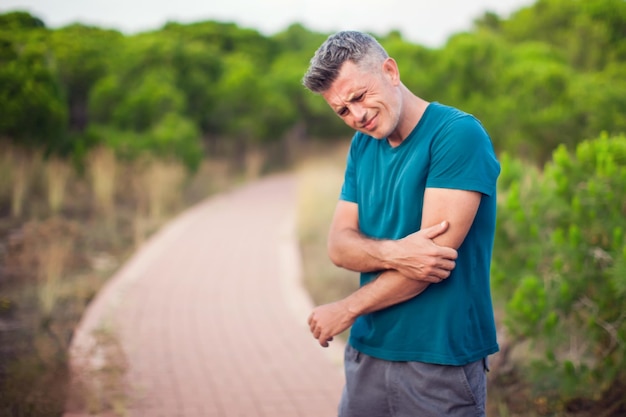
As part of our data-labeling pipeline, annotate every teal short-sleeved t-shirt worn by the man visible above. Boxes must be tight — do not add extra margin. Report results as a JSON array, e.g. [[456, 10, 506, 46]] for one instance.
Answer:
[[340, 103, 500, 365]]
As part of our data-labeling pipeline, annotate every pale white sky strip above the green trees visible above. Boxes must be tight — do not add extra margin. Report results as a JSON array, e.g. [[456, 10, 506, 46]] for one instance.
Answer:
[[0, 0, 534, 47]]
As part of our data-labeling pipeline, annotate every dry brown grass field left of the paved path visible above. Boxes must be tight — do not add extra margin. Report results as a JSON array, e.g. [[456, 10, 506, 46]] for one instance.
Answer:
[[0, 147, 239, 417]]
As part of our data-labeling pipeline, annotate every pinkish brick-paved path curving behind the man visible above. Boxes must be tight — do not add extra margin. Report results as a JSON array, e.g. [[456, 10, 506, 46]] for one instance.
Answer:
[[66, 175, 343, 417]]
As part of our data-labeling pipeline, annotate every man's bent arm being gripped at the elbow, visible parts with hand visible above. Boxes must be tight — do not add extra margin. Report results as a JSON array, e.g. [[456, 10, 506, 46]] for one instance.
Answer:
[[309, 188, 482, 347]]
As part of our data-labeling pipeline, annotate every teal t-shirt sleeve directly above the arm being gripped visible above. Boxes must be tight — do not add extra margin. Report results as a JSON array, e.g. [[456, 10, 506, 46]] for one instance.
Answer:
[[426, 115, 500, 196]]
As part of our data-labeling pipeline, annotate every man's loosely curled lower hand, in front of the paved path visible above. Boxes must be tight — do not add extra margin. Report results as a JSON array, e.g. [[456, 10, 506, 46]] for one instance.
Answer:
[[309, 300, 357, 347]]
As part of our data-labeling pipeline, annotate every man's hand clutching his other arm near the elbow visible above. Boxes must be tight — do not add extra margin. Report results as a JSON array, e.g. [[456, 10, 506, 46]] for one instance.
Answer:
[[388, 221, 457, 283]]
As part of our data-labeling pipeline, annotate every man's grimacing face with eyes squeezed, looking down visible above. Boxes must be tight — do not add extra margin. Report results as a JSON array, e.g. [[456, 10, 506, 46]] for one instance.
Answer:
[[322, 59, 402, 139]]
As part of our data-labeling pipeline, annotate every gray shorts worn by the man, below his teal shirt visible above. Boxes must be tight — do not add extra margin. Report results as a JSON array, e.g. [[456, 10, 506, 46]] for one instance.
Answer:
[[339, 345, 487, 417]]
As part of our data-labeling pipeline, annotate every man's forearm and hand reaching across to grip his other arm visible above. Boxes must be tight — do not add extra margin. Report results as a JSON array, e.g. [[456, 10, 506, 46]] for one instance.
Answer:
[[328, 200, 457, 282]]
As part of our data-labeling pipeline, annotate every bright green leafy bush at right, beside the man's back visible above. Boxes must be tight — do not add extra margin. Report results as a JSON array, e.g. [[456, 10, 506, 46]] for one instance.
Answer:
[[493, 134, 626, 406]]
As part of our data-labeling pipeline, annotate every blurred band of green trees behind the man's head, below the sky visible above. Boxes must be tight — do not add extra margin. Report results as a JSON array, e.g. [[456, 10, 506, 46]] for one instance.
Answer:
[[0, 0, 626, 166]]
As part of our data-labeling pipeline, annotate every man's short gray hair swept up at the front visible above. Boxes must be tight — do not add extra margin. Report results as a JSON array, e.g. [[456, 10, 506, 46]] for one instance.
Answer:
[[302, 31, 389, 93]]
